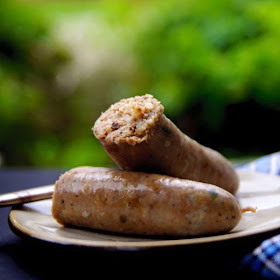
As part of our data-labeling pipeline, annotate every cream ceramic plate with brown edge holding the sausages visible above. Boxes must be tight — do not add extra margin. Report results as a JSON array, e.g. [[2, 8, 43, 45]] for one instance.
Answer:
[[9, 171, 280, 250]]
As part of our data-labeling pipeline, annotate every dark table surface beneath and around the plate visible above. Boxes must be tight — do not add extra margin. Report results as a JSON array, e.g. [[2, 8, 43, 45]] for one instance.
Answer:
[[0, 168, 280, 280]]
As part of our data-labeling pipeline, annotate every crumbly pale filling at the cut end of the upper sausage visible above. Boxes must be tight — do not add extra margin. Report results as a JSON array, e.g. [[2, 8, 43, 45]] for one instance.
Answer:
[[93, 94, 163, 145]]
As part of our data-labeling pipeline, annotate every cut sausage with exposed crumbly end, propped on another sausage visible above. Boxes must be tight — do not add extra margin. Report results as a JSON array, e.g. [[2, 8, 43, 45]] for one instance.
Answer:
[[93, 94, 239, 194]]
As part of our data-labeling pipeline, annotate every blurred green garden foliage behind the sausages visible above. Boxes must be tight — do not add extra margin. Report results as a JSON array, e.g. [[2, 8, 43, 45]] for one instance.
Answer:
[[0, 0, 280, 168]]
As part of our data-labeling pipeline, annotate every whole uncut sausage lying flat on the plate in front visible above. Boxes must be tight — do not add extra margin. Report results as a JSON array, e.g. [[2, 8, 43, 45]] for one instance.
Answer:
[[52, 167, 241, 236]]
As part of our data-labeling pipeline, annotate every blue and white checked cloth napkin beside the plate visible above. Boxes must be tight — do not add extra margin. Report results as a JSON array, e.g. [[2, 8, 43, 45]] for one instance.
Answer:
[[236, 152, 280, 279]]
